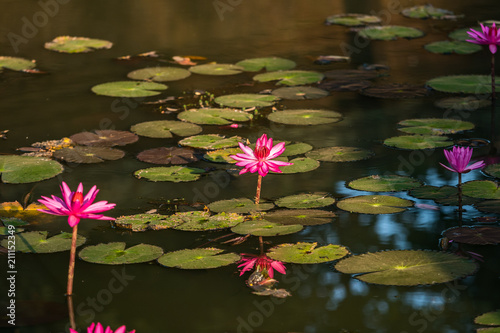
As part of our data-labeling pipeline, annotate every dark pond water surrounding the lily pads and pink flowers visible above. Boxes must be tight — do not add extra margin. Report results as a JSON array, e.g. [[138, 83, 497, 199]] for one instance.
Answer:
[[0, 0, 500, 333]]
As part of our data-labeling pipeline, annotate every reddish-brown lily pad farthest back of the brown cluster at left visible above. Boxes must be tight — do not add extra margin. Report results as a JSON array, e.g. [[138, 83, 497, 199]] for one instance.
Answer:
[[70, 130, 139, 147]]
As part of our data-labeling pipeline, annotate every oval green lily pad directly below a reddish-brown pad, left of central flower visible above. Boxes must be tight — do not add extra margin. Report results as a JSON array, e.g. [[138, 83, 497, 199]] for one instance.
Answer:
[[134, 166, 205, 183]]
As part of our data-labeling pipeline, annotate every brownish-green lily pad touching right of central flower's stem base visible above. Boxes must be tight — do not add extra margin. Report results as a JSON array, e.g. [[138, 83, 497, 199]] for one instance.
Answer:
[[264, 209, 337, 225]]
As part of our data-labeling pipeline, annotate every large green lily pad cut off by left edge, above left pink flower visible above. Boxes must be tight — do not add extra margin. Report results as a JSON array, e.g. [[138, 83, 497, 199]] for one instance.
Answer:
[[0, 155, 64, 184]]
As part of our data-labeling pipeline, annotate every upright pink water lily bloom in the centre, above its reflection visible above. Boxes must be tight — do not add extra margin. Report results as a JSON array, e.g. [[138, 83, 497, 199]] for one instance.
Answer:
[[230, 134, 293, 177]]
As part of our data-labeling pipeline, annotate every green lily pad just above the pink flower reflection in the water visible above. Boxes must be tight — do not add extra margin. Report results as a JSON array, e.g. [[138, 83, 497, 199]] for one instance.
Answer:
[[231, 220, 303, 237]]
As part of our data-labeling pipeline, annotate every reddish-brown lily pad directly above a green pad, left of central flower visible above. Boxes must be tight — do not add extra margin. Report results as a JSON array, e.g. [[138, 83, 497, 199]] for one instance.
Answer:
[[137, 147, 198, 164]]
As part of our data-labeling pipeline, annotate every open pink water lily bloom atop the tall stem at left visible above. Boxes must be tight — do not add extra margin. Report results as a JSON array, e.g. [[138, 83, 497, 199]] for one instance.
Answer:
[[38, 182, 115, 227]]
